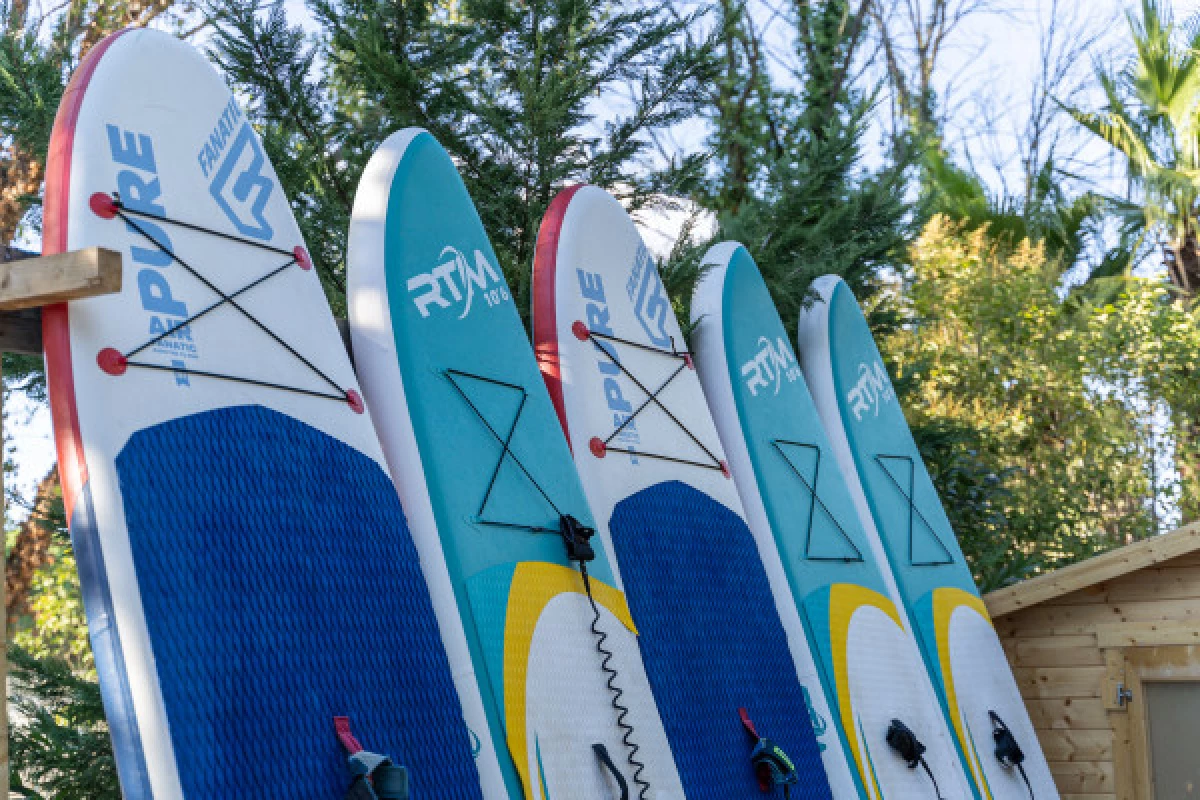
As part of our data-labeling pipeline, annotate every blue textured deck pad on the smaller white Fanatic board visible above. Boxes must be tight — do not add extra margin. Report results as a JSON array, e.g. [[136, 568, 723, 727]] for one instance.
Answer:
[[610, 481, 832, 800]]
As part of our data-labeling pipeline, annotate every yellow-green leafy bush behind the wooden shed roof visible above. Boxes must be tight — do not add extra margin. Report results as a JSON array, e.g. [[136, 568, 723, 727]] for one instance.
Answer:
[[881, 217, 1200, 590]]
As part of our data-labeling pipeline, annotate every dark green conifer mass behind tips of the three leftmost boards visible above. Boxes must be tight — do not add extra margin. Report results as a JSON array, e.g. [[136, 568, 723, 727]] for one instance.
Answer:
[[212, 0, 709, 326]]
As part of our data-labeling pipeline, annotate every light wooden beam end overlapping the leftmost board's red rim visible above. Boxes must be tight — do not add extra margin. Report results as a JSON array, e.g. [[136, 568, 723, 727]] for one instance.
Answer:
[[0, 247, 121, 311]]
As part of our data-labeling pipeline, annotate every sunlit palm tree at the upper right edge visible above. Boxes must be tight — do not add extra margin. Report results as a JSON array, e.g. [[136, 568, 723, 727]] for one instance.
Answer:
[[1067, 0, 1200, 299]]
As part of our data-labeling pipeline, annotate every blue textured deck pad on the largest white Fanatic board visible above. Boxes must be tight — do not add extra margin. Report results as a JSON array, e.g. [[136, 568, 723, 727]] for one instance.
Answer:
[[116, 403, 481, 800]]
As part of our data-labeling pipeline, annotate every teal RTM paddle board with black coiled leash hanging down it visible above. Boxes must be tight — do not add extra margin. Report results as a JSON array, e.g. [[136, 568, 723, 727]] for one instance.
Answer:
[[348, 128, 683, 800]]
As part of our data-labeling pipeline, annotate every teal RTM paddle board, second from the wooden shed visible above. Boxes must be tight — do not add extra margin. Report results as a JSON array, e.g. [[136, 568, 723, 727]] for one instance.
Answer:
[[691, 242, 970, 800]]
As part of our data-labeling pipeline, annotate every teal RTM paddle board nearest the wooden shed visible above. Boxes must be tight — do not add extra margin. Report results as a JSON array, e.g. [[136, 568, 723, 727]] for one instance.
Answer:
[[799, 276, 1058, 800]]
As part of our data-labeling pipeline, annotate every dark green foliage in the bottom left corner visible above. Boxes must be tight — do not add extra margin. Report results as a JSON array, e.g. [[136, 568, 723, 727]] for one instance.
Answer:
[[8, 646, 121, 800]]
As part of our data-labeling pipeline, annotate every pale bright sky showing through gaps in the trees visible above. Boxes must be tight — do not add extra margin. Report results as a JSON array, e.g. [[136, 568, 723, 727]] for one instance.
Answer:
[[6, 0, 1200, 516]]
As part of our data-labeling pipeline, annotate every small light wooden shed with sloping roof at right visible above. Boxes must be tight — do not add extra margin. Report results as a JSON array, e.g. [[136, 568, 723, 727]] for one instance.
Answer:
[[984, 524, 1200, 800]]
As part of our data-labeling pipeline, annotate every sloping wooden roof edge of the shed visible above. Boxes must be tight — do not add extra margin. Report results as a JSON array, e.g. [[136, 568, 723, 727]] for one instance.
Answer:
[[984, 523, 1200, 618]]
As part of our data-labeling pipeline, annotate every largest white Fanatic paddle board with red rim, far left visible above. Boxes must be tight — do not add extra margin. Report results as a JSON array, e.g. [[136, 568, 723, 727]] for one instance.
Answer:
[[43, 30, 482, 800]]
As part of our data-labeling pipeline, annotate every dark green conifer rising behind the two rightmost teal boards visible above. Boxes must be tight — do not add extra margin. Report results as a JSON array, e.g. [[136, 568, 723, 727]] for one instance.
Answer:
[[703, 0, 910, 331]]
